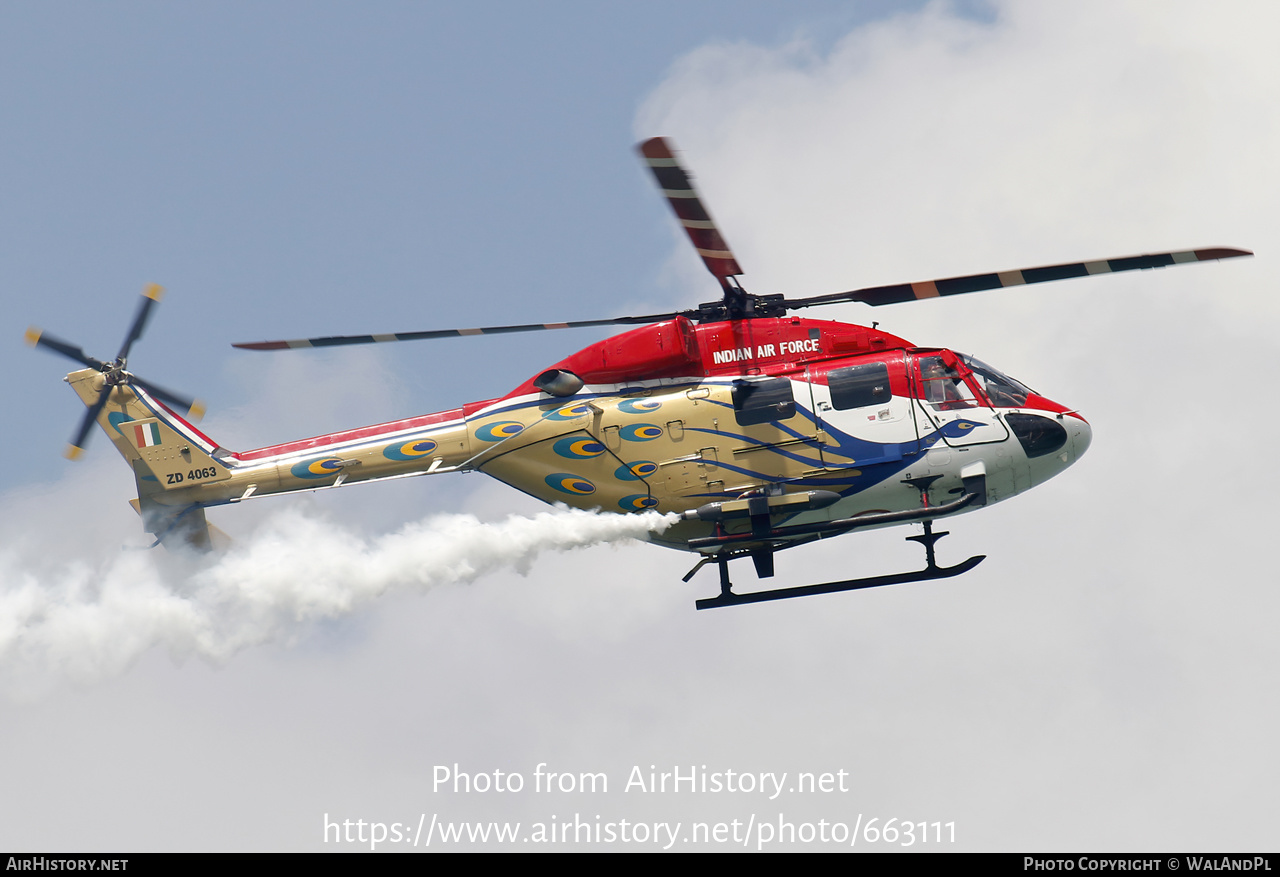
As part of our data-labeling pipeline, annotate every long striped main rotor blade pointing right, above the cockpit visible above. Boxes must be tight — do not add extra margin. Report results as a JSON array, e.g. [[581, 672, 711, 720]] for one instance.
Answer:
[[783, 247, 1253, 309]]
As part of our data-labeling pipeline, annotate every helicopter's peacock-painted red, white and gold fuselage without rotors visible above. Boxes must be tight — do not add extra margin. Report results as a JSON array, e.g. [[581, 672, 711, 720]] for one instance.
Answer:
[[80, 316, 1091, 548]]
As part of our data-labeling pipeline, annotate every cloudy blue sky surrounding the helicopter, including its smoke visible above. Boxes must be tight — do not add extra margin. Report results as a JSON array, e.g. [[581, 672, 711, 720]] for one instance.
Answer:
[[0, 0, 1280, 851]]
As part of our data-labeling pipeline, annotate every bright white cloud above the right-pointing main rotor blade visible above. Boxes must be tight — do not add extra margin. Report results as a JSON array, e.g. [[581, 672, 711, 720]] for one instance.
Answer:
[[636, 3, 1280, 307]]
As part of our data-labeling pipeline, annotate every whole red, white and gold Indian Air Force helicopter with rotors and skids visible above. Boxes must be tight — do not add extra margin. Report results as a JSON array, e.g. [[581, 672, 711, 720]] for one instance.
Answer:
[[27, 137, 1252, 609]]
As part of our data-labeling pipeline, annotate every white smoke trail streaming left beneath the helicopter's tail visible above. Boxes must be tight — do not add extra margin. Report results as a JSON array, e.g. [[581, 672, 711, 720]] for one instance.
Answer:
[[0, 507, 676, 684]]
